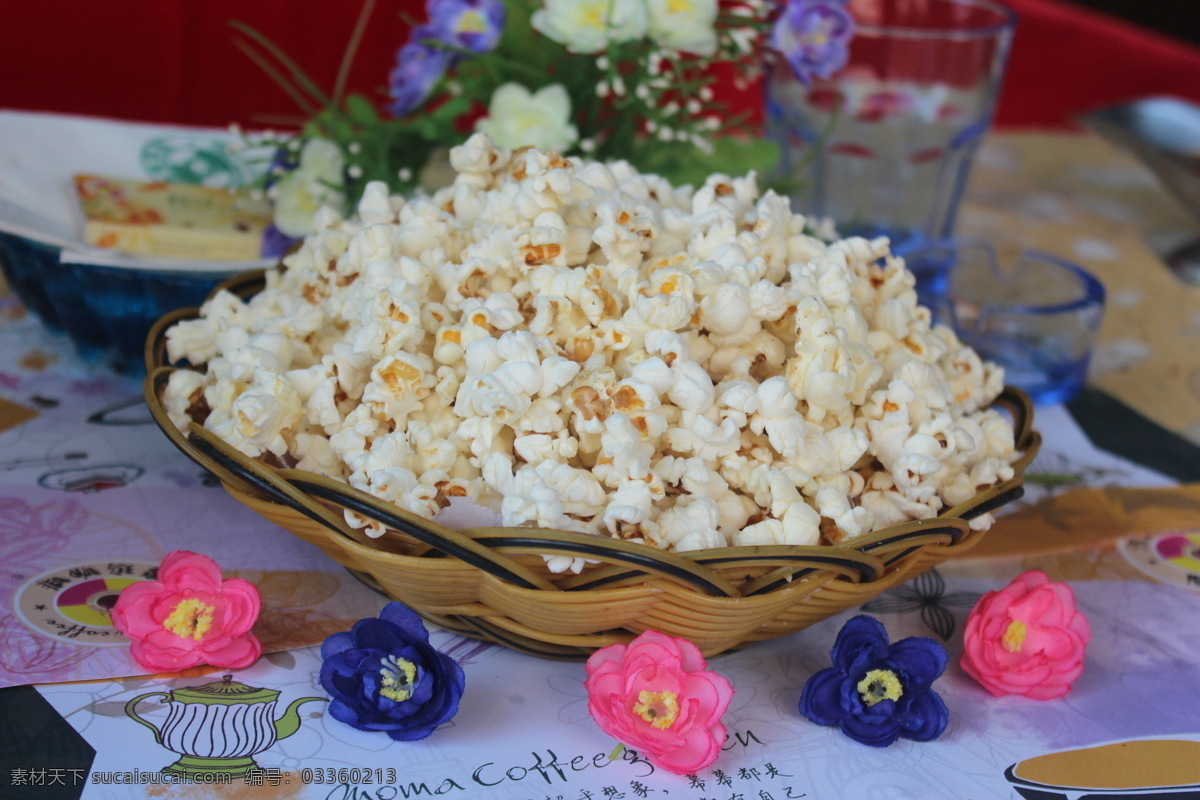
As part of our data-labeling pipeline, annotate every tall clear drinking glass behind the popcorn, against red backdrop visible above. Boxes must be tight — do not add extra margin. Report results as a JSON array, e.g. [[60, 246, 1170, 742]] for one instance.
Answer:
[[767, 0, 1015, 252]]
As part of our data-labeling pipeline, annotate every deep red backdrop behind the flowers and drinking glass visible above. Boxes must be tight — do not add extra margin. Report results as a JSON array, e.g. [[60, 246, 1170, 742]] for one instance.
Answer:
[[0, 0, 1200, 127]]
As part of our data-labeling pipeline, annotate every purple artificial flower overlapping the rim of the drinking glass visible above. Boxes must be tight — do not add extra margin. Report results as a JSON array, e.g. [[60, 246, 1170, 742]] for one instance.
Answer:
[[770, 0, 854, 85]]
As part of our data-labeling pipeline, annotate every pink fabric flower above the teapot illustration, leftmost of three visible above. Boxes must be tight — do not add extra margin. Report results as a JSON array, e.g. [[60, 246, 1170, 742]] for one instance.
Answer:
[[112, 551, 263, 673]]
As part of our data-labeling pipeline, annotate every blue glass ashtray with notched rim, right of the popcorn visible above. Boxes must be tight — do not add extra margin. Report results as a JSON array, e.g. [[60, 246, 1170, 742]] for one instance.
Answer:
[[905, 242, 1104, 405]]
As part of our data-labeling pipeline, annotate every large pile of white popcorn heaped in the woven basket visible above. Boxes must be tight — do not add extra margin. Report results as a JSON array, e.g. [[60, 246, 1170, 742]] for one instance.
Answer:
[[163, 134, 1015, 570]]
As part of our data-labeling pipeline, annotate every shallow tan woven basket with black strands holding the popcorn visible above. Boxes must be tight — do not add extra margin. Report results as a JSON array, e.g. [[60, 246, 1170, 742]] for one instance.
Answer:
[[145, 272, 1040, 658]]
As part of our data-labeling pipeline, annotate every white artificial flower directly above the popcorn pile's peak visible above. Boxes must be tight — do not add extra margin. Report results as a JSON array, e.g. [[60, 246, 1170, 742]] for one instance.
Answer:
[[475, 83, 580, 150]]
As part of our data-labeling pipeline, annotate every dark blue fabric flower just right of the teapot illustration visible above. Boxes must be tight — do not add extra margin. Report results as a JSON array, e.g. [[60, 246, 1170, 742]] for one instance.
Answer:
[[320, 602, 466, 741]]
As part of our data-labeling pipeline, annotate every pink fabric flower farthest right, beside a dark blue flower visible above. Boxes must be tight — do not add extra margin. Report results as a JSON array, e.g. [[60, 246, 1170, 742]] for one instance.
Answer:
[[960, 570, 1092, 700]]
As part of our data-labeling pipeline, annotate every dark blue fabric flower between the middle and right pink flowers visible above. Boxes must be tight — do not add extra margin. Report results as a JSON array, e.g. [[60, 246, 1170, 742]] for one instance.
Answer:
[[800, 614, 949, 747]]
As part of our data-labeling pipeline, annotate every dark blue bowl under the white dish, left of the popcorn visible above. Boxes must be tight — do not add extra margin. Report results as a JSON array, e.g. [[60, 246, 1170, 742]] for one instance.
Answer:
[[0, 231, 245, 375]]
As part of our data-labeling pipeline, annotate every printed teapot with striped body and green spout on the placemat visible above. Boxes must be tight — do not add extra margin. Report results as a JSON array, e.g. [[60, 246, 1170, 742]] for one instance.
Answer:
[[125, 675, 326, 777]]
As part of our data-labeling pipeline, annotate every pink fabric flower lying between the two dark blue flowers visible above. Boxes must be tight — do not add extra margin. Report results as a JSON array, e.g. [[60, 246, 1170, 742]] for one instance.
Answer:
[[587, 631, 733, 775]]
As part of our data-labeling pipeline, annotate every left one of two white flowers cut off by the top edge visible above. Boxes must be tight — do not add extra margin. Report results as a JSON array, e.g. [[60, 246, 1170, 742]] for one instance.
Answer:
[[532, 0, 647, 53]]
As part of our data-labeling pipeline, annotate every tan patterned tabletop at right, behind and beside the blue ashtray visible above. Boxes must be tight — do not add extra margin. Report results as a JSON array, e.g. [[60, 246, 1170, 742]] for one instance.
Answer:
[[958, 133, 1200, 443]]
